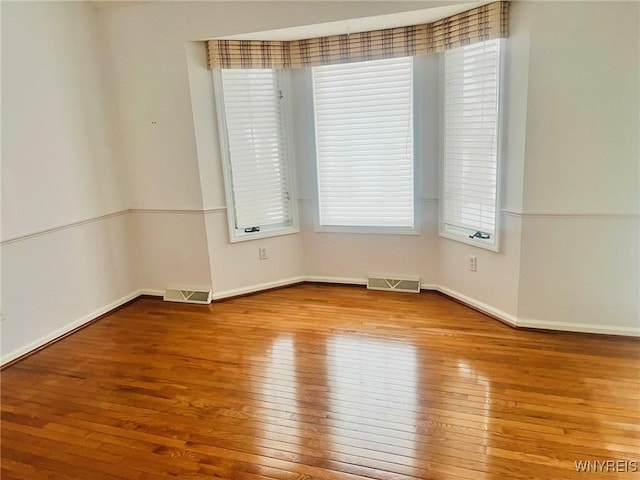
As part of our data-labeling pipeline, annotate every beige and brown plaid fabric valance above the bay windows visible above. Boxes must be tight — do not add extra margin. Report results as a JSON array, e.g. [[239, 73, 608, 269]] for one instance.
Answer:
[[207, 2, 509, 69]]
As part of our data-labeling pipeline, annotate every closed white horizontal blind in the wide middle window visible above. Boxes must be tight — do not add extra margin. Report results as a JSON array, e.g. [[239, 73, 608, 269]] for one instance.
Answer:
[[313, 57, 414, 228]]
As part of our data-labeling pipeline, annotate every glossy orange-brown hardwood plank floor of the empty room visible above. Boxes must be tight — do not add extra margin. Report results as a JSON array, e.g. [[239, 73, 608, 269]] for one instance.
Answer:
[[1, 284, 640, 480]]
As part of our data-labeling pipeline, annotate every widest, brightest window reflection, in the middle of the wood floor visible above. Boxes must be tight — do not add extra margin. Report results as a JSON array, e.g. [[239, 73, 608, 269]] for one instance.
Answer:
[[327, 335, 418, 467]]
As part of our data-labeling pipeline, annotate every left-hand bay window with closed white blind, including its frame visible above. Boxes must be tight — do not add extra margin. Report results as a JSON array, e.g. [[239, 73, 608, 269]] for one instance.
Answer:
[[215, 69, 297, 242]]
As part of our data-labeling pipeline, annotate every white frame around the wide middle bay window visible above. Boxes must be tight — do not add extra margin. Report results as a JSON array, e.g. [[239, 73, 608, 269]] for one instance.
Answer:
[[307, 56, 423, 235]]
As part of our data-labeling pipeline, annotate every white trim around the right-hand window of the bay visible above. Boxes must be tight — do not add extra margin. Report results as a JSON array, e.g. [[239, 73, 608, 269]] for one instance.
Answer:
[[438, 38, 507, 253]]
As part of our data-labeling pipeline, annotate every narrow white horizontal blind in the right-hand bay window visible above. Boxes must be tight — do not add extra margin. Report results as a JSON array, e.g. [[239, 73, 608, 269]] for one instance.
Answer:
[[443, 39, 501, 239]]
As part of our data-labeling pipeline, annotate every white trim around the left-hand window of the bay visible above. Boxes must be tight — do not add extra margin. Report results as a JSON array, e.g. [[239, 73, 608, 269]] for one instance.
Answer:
[[212, 69, 300, 243]]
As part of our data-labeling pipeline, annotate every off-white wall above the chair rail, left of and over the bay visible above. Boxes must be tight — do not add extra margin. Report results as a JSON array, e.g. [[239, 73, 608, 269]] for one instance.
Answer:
[[102, 2, 444, 209]]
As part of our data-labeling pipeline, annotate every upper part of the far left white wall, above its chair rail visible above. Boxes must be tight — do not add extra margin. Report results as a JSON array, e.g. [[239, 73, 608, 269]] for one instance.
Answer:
[[2, 2, 128, 238]]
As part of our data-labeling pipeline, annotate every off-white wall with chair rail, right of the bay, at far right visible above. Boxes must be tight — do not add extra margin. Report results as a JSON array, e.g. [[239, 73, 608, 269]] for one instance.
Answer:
[[518, 2, 640, 335]]
